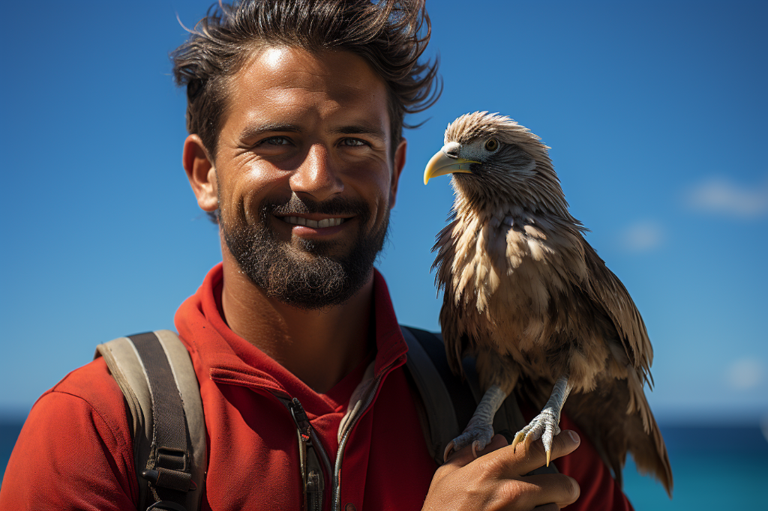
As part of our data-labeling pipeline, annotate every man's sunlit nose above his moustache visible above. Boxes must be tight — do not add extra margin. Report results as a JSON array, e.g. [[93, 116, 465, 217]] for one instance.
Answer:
[[290, 144, 344, 201]]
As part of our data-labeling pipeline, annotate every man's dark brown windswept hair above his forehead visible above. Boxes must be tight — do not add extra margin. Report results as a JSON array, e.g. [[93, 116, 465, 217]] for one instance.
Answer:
[[171, 0, 441, 159]]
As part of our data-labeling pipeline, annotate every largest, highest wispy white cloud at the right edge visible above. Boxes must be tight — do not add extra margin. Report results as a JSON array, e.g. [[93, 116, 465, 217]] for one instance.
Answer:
[[685, 178, 768, 218]]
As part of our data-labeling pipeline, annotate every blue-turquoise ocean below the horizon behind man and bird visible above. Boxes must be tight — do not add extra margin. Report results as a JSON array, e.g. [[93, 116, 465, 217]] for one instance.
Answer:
[[0, 419, 768, 511]]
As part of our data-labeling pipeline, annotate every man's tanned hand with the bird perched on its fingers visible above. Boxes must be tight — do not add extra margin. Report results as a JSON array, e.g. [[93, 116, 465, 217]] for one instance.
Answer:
[[423, 431, 579, 511]]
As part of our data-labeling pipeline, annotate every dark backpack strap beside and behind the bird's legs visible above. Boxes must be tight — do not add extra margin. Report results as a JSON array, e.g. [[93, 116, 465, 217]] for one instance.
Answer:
[[400, 325, 557, 474]]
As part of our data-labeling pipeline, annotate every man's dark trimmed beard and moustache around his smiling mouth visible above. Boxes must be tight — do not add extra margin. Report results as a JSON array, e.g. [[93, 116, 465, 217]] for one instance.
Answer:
[[219, 195, 389, 309]]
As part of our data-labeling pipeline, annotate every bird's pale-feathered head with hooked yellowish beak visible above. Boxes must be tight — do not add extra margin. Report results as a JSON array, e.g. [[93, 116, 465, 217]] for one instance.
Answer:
[[424, 112, 568, 215]]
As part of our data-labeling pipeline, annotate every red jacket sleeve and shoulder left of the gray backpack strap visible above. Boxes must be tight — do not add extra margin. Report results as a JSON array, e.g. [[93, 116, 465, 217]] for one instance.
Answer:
[[0, 360, 138, 509]]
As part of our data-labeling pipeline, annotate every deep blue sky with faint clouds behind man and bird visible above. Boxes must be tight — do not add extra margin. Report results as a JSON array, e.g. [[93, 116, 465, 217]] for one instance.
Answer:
[[0, 0, 768, 421]]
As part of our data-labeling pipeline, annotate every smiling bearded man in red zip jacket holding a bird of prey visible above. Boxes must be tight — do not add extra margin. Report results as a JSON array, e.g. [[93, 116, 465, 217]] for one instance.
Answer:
[[0, 0, 629, 510]]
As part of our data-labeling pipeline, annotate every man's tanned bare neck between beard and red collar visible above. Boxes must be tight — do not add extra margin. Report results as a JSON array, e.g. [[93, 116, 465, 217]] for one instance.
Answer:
[[221, 254, 373, 394]]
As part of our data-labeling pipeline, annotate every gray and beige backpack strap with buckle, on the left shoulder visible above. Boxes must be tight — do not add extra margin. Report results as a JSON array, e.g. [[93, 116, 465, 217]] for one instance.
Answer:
[[95, 330, 207, 511]]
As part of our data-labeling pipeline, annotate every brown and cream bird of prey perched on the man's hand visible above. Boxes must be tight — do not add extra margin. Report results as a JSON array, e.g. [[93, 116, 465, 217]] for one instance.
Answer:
[[424, 112, 673, 498]]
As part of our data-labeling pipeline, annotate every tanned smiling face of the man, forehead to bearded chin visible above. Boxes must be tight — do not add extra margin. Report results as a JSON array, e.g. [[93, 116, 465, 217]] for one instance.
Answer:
[[207, 47, 405, 308]]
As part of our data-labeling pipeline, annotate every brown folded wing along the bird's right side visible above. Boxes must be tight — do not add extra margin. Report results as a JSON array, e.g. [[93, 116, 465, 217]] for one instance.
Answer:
[[583, 241, 653, 385]]
